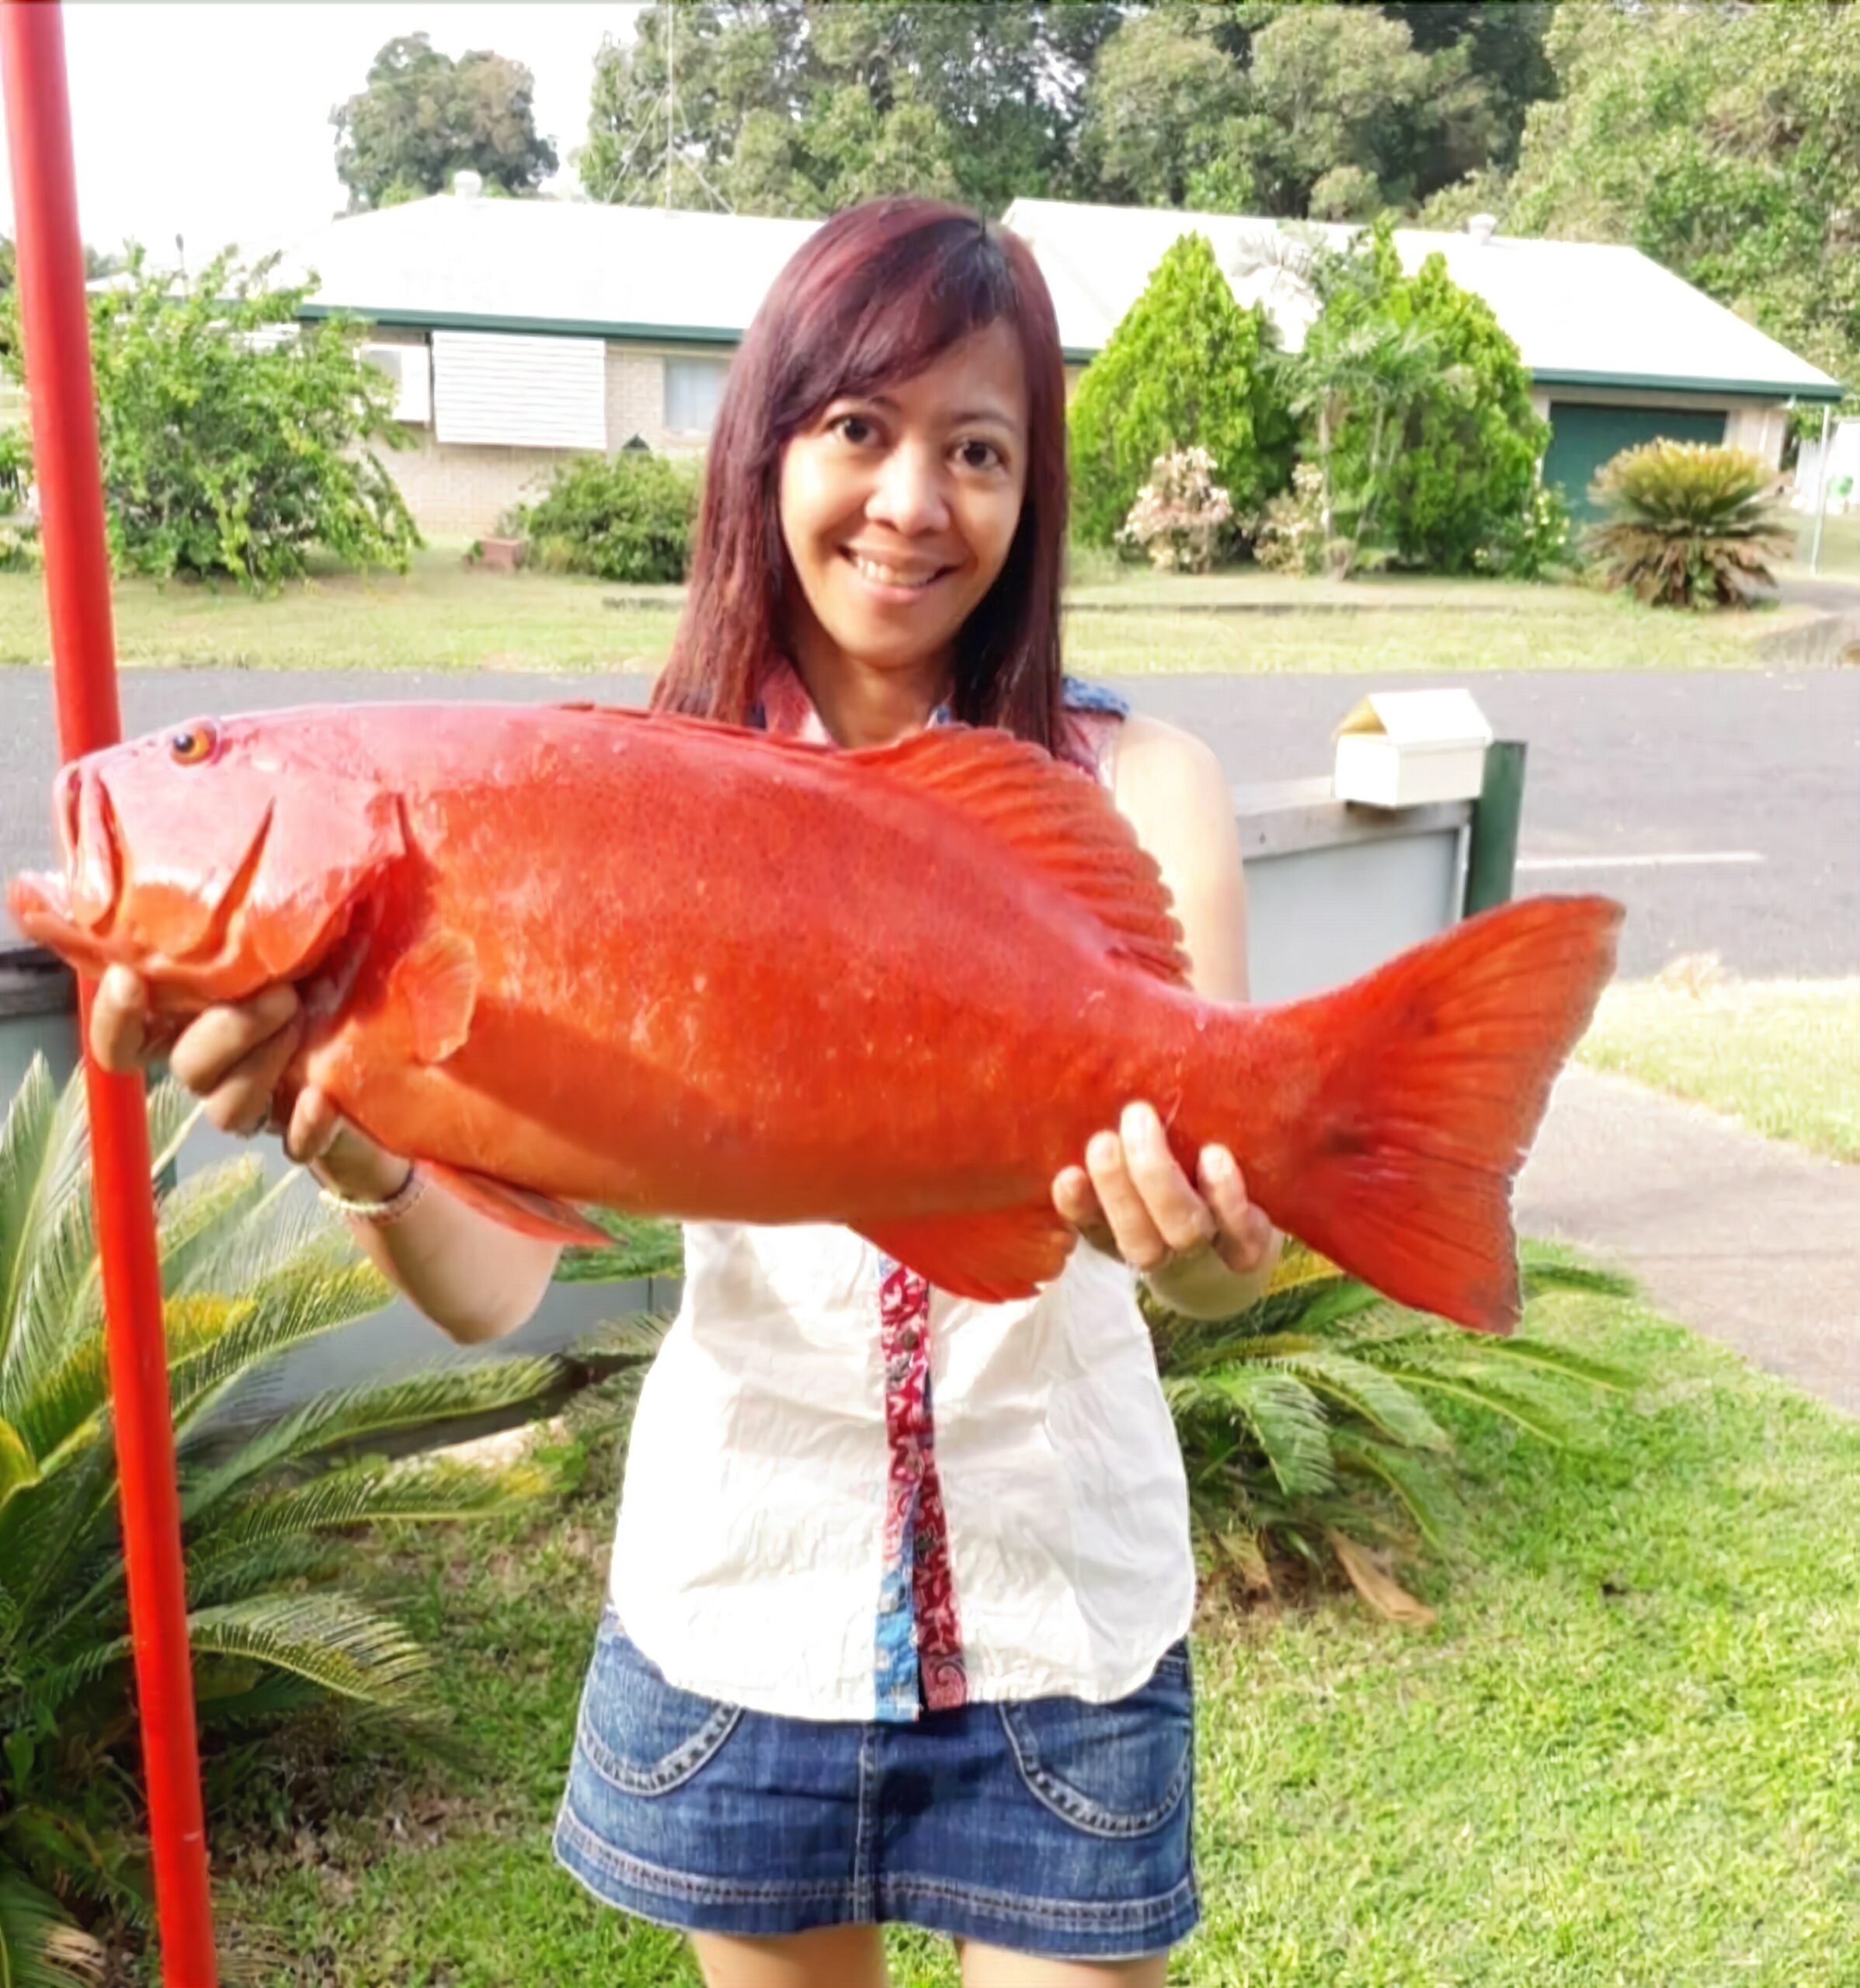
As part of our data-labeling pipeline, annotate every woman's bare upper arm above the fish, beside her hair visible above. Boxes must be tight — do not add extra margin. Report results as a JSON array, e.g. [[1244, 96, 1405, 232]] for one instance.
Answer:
[[1113, 716, 1246, 1000]]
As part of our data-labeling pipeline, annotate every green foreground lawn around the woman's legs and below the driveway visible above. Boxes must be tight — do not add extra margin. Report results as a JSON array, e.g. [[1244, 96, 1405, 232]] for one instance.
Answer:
[[203, 1298, 1860, 1988]]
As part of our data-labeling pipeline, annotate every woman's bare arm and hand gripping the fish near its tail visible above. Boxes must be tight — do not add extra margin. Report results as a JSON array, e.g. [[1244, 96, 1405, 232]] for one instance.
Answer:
[[1053, 718, 1280, 1318]]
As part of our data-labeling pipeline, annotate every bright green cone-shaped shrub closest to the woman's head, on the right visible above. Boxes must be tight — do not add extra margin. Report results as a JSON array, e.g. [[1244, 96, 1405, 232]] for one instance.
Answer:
[[1071, 235, 1295, 544]]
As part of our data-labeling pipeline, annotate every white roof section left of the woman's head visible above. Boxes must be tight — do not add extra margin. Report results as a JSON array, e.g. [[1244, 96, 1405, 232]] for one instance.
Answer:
[[266, 193, 819, 344]]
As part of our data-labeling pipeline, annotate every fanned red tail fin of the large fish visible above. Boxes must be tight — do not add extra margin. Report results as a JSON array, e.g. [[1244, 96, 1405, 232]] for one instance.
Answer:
[[1236, 897, 1622, 1332]]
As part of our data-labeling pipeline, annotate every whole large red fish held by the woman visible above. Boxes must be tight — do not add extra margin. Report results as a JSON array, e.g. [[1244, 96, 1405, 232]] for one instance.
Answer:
[[8, 704, 1622, 1332]]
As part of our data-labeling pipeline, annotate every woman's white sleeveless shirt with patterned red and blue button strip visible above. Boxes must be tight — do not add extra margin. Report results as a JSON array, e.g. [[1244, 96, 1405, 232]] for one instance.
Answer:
[[610, 676, 1194, 1719]]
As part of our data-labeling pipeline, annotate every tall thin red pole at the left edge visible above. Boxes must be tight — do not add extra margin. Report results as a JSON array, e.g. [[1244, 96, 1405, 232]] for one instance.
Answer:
[[0, 0, 218, 1988]]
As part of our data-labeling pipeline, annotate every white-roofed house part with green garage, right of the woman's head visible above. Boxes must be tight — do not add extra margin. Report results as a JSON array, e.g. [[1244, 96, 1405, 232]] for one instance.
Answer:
[[1003, 201, 1842, 513]]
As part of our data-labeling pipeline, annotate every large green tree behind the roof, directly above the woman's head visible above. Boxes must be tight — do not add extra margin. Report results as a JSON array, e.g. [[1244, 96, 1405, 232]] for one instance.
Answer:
[[579, 0, 1117, 214]]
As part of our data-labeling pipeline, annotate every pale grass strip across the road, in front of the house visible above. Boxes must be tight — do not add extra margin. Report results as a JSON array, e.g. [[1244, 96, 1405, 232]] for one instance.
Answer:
[[0, 544, 1806, 676]]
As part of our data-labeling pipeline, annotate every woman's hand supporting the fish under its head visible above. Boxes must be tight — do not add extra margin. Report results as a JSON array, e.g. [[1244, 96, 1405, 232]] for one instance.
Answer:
[[89, 966, 408, 1201]]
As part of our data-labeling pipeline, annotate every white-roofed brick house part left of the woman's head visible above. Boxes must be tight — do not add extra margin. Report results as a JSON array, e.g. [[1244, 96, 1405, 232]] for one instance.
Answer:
[[264, 173, 817, 537]]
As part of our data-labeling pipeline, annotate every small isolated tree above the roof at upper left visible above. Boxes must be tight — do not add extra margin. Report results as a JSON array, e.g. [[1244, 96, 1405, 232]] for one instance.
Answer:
[[330, 34, 556, 209]]
